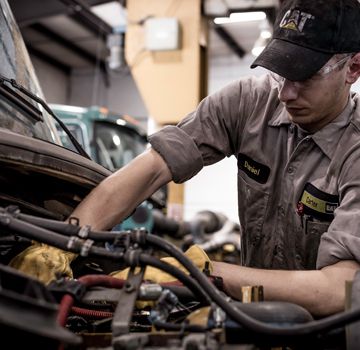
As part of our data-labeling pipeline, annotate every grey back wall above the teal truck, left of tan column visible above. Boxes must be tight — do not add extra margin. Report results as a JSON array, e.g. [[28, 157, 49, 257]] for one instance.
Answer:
[[31, 55, 148, 128]]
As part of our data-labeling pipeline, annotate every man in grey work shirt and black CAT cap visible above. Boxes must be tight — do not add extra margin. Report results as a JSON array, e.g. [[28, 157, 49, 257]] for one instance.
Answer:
[[9, 0, 360, 316]]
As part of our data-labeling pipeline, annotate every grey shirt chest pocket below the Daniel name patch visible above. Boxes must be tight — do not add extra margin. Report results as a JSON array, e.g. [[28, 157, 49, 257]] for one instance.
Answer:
[[238, 173, 269, 265]]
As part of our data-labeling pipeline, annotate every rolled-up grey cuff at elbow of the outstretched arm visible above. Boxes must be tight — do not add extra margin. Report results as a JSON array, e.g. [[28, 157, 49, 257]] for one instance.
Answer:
[[149, 126, 204, 183]]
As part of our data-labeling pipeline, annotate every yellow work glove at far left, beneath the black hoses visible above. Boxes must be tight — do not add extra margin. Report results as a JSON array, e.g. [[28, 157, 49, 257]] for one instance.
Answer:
[[9, 243, 76, 284]]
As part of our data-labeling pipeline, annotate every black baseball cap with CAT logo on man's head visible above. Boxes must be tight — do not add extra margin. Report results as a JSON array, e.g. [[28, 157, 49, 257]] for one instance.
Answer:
[[251, 0, 360, 81]]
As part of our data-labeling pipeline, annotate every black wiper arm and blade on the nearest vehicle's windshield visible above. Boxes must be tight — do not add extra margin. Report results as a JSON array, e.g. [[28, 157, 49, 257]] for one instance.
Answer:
[[0, 74, 91, 159]]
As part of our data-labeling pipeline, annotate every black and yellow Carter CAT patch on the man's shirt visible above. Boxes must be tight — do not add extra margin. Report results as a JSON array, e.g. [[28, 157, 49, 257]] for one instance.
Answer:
[[300, 182, 339, 221]]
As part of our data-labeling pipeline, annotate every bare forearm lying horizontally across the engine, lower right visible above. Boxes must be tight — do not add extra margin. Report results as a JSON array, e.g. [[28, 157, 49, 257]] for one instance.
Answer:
[[213, 261, 360, 316]]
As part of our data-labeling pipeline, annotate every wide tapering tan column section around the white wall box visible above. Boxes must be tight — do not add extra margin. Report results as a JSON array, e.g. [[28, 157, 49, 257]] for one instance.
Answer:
[[125, 0, 202, 125]]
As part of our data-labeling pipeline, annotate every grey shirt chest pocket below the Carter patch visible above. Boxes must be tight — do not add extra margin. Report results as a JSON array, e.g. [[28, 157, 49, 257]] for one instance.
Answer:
[[300, 220, 330, 270]]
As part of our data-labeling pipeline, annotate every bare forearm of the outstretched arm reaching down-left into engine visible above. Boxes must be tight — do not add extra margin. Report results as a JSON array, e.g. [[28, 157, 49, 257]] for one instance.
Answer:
[[71, 149, 171, 230]]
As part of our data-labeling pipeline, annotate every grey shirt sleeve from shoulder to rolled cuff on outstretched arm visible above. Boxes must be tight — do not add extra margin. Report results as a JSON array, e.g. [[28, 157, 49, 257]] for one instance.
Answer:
[[149, 77, 265, 183]]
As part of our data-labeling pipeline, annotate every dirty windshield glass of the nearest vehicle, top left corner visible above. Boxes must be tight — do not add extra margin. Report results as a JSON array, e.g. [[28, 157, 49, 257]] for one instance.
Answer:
[[0, 0, 61, 145]]
